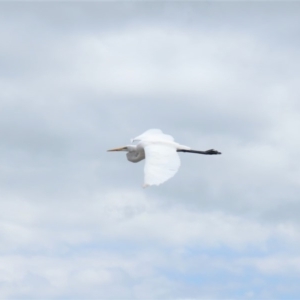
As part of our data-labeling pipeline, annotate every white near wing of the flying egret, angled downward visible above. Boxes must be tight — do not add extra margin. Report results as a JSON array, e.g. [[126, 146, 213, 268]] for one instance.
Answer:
[[143, 143, 180, 187]]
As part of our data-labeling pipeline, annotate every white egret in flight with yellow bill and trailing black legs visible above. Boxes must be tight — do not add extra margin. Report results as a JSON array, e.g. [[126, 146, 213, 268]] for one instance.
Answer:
[[107, 129, 221, 188]]
